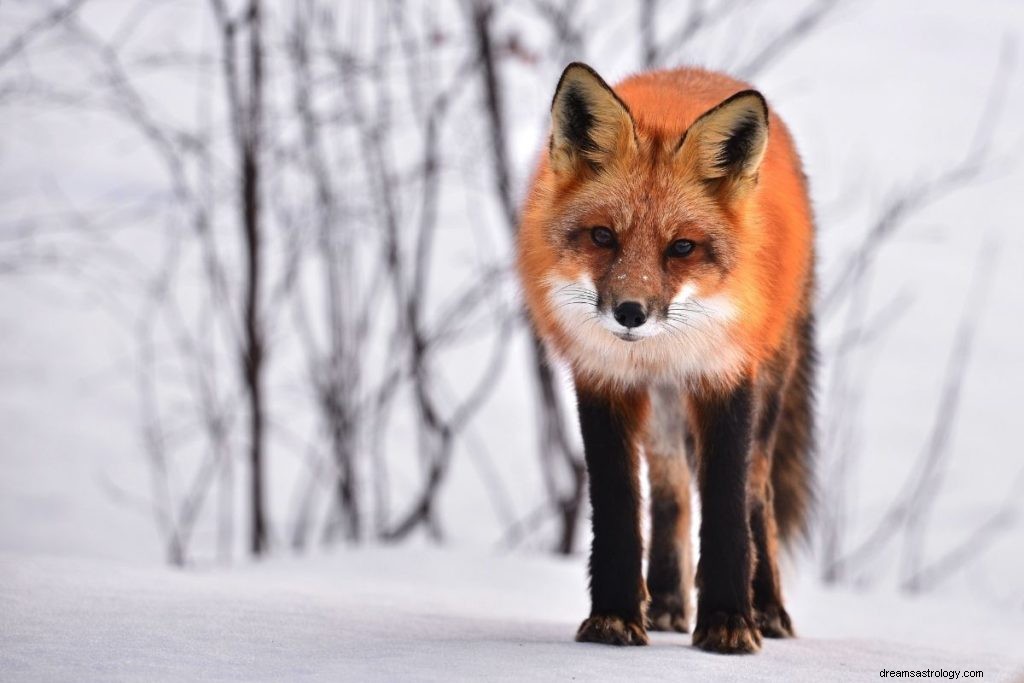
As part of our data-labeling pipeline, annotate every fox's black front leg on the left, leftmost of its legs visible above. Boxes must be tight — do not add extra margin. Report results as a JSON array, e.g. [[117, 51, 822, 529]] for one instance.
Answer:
[[577, 381, 648, 645]]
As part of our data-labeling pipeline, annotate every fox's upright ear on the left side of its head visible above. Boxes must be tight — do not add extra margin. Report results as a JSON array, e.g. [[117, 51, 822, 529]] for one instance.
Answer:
[[549, 61, 636, 173]]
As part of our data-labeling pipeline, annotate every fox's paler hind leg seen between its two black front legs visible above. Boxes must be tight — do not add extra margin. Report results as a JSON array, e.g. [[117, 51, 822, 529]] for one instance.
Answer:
[[644, 387, 693, 633]]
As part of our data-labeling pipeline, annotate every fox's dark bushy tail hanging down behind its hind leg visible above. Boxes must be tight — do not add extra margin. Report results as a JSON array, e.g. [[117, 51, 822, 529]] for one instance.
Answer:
[[771, 316, 817, 546]]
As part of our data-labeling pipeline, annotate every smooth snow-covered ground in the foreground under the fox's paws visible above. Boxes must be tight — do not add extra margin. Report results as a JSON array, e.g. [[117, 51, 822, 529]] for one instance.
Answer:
[[0, 549, 1024, 681]]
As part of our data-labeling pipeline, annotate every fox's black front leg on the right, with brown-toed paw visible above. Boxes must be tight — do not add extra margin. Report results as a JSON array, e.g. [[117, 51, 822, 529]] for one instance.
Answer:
[[690, 381, 761, 653]]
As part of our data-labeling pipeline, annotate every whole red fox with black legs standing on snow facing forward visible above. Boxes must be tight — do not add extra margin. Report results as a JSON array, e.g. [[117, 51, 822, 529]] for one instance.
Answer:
[[518, 63, 815, 652]]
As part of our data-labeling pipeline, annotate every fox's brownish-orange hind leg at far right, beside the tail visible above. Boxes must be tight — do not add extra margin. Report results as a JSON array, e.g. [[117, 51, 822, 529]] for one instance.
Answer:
[[748, 383, 795, 638]]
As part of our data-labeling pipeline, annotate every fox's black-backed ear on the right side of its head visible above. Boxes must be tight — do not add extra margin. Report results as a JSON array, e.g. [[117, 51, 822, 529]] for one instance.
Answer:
[[678, 90, 768, 194]]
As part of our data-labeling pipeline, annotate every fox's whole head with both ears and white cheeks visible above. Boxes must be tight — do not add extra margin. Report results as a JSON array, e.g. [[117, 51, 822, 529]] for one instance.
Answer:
[[521, 65, 768, 384]]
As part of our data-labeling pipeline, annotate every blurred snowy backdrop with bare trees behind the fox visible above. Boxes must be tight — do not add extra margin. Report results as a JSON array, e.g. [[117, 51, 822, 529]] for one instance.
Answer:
[[0, 0, 1024, 609]]
